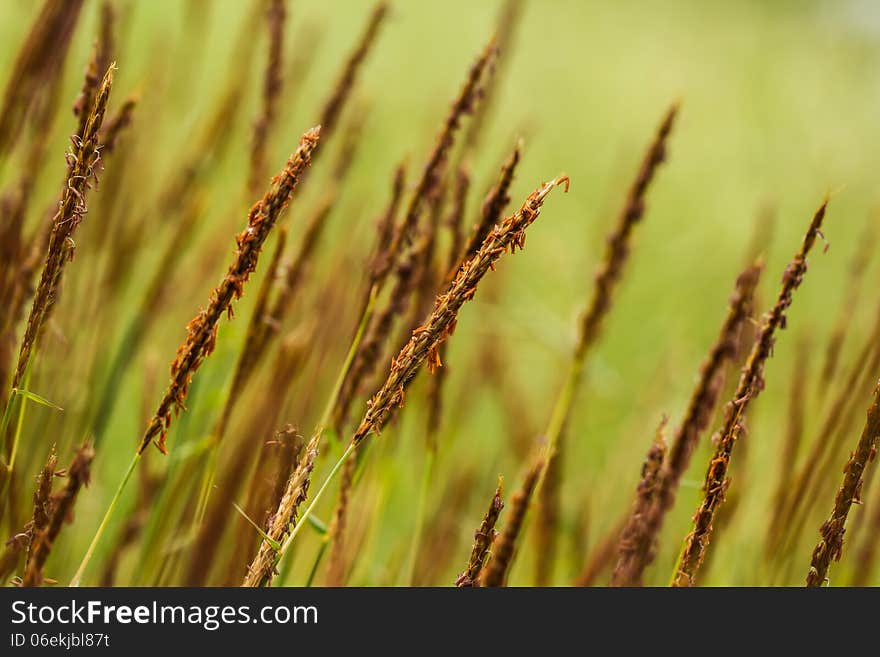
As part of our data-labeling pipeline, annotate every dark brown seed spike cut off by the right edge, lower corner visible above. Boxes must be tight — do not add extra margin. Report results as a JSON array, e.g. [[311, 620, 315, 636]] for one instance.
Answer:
[[807, 383, 880, 587]]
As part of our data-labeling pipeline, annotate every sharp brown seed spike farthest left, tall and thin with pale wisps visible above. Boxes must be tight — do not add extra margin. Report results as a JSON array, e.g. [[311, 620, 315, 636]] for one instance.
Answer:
[[12, 65, 114, 388]]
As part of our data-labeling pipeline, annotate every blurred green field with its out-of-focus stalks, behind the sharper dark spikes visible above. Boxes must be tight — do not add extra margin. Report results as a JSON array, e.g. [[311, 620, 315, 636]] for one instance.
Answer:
[[0, 0, 880, 586]]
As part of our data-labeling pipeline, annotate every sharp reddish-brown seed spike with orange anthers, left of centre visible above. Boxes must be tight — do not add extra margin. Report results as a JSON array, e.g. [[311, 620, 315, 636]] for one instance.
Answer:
[[138, 128, 320, 453]]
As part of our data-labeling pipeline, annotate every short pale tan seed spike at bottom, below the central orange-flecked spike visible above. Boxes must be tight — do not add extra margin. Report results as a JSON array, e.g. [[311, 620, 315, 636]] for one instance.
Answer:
[[242, 432, 321, 587]]
